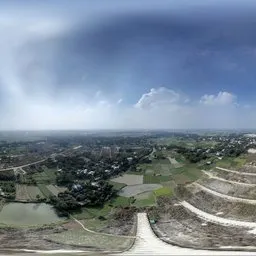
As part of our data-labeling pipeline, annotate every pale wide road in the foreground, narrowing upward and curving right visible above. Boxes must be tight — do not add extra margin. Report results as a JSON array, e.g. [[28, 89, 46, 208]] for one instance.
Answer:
[[116, 213, 255, 256]]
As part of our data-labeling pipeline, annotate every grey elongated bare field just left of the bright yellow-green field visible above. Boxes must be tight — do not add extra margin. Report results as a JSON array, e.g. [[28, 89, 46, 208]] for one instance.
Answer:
[[119, 184, 162, 197]]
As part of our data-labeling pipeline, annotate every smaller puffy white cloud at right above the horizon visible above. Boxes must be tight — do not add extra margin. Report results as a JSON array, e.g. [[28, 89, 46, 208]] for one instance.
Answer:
[[200, 92, 237, 106]]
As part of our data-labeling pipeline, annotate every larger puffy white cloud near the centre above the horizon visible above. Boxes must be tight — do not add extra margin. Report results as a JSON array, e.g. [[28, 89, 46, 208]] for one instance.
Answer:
[[135, 87, 180, 109]]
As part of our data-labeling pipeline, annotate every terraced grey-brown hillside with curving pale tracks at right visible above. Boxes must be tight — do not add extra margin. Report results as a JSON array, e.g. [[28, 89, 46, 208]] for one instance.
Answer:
[[149, 162, 256, 249]]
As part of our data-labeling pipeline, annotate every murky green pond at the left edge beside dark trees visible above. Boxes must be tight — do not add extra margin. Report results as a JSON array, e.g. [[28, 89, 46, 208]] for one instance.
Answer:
[[0, 203, 64, 226]]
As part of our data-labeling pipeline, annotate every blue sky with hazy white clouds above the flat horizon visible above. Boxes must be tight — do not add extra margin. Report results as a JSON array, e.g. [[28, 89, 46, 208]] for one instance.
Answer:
[[0, 0, 256, 130]]
